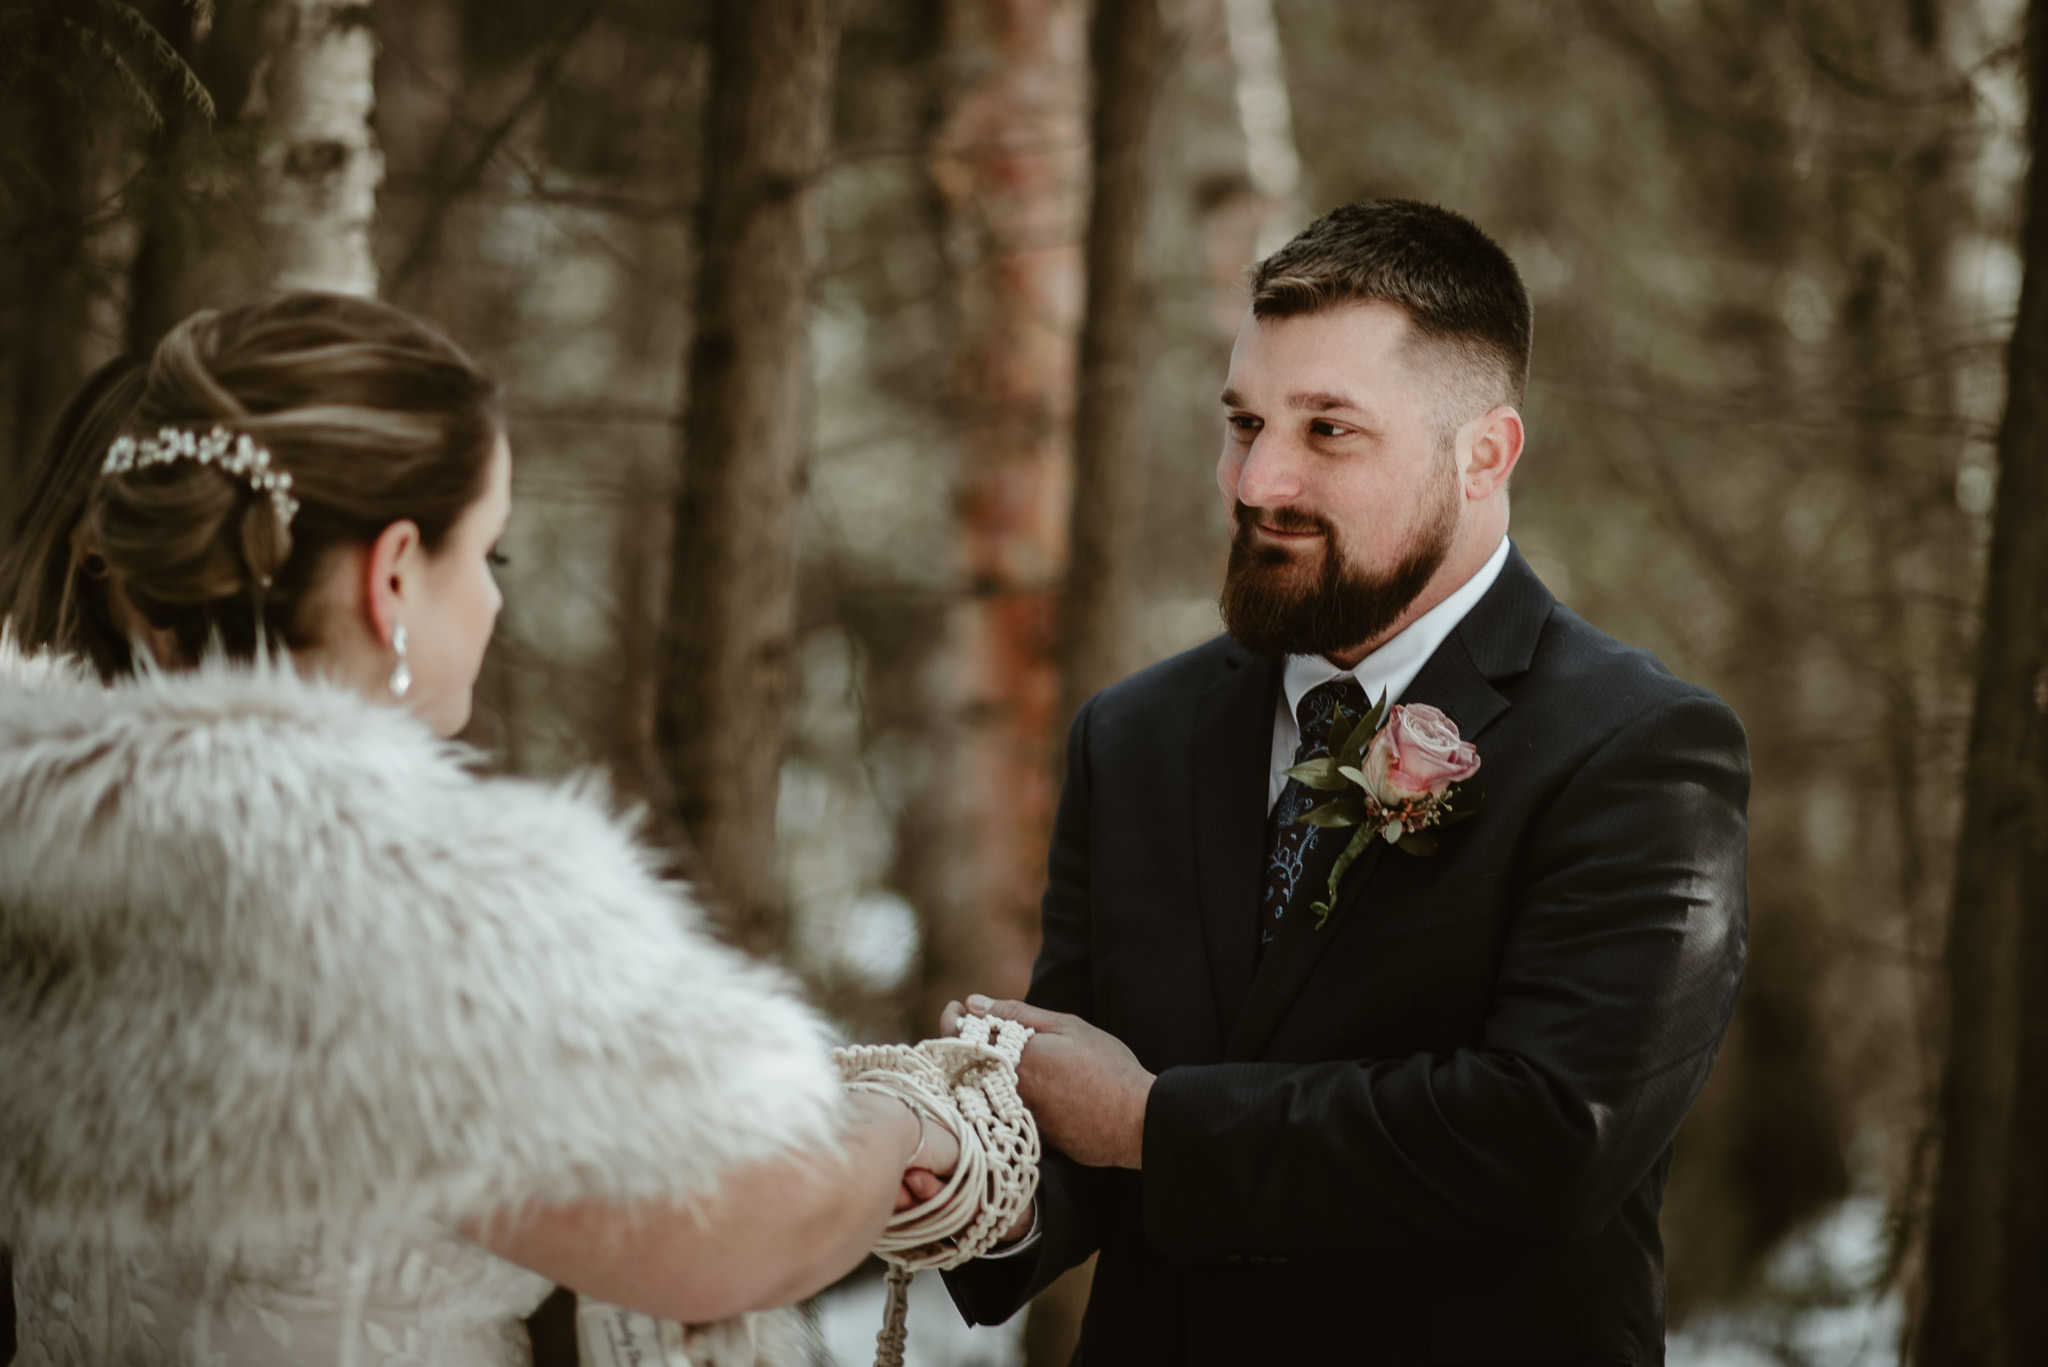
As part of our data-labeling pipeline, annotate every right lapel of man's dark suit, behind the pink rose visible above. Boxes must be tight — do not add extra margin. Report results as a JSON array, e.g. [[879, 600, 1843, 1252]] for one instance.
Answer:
[[1225, 549, 1556, 1062]]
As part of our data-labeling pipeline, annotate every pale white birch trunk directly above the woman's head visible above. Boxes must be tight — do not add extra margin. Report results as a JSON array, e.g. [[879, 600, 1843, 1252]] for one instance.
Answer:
[[244, 0, 383, 295]]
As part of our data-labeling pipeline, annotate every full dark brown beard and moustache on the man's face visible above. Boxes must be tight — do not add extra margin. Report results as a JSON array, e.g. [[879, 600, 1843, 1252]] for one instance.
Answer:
[[1223, 465, 1458, 656]]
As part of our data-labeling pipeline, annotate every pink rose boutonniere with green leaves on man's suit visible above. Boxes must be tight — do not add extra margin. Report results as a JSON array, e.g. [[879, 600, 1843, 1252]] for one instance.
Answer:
[[1286, 693, 1479, 930]]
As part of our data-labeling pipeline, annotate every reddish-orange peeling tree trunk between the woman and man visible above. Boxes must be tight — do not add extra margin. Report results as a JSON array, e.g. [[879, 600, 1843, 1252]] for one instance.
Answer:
[[932, 0, 1085, 996]]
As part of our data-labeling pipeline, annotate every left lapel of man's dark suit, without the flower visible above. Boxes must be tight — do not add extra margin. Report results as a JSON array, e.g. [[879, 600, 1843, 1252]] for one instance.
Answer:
[[1190, 652, 1280, 1039]]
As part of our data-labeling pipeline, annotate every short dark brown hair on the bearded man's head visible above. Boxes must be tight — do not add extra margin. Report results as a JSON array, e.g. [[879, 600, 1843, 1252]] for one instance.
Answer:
[[1251, 199, 1530, 404]]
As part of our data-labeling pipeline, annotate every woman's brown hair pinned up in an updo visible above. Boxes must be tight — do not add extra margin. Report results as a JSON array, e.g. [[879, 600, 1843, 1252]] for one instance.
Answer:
[[72, 293, 500, 662]]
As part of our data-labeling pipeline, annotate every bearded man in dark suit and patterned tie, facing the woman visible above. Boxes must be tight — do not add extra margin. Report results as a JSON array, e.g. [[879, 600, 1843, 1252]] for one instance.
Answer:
[[948, 201, 1749, 1367]]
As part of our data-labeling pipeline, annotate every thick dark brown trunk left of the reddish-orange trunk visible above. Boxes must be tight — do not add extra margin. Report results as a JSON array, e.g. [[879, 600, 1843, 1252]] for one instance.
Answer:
[[655, 0, 840, 951]]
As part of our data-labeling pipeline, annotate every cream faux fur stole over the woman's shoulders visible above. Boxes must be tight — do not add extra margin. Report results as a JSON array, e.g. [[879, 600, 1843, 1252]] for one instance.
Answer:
[[0, 648, 842, 1244]]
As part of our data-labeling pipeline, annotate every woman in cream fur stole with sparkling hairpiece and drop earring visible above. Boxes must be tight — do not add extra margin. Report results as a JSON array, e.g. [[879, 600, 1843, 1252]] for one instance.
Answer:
[[0, 295, 958, 1367]]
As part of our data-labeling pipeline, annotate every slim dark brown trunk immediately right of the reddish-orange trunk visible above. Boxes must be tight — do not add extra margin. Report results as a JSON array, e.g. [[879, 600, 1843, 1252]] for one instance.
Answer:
[[1059, 0, 1165, 721]]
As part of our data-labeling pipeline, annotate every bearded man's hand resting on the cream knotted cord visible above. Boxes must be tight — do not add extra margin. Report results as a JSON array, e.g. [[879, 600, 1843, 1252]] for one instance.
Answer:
[[942, 996, 1153, 1168]]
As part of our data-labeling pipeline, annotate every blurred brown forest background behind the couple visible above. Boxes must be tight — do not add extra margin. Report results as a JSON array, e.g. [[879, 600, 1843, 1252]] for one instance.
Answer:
[[0, 0, 2048, 1365]]
